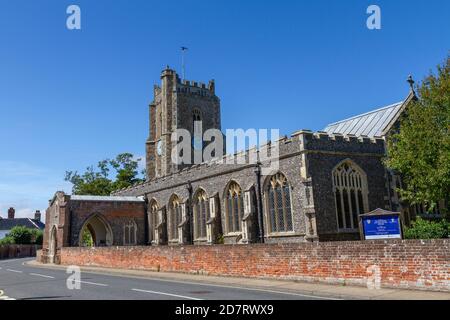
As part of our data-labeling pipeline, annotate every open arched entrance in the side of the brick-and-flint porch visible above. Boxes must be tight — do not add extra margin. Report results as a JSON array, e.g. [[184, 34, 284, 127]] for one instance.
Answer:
[[79, 214, 113, 247]]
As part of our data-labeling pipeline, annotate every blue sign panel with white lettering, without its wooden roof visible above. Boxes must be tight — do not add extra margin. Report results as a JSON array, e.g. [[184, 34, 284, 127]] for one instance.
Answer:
[[362, 215, 402, 240]]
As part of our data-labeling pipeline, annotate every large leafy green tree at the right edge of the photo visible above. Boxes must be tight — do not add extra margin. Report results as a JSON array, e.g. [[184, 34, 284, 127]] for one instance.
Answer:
[[386, 57, 450, 211]]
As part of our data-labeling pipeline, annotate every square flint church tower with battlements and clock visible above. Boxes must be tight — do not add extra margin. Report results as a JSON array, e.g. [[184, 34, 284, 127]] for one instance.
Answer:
[[146, 67, 221, 180]]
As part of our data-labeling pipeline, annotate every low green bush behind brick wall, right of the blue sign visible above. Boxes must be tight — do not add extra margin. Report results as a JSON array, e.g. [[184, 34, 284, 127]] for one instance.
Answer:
[[404, 217, 450, 239]]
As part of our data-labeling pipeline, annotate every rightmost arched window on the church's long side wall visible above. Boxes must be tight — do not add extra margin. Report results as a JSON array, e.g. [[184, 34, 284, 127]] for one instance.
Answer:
[[266, 173, 294, 233]]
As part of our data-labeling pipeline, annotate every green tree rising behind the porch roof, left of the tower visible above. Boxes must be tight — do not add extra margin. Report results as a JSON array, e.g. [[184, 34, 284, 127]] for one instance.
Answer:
[[65, 153, 143, 196]]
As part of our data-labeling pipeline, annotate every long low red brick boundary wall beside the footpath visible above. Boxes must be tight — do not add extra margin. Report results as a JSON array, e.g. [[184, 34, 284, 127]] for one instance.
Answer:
[[61, 239, 450, 292]]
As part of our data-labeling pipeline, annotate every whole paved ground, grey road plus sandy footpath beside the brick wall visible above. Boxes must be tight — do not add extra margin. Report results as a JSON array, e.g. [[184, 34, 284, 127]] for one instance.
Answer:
[[0, 258, 450, 300]]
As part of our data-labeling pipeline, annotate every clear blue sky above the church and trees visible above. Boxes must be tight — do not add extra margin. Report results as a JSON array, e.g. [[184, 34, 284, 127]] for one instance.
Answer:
[[0, 0, 450, 220]]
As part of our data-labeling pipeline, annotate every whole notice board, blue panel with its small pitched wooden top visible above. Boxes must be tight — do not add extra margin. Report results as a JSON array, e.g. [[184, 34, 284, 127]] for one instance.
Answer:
[[359, 209, 403, 240]]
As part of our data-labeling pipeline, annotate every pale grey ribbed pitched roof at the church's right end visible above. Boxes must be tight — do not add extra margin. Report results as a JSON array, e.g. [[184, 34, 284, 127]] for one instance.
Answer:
[[323, 101, 405, 138]]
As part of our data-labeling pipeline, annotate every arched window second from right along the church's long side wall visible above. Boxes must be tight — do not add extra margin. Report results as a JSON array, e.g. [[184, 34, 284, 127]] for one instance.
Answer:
[[225, 181, 244, 233]]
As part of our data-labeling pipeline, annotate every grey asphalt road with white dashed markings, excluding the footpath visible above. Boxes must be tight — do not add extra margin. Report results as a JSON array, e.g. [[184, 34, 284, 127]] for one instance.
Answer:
[[0, 258, 338, 300]]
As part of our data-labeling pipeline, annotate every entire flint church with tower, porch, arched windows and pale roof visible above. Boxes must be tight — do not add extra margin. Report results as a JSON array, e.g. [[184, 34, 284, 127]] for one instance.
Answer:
[[42, 67, 434, 262]]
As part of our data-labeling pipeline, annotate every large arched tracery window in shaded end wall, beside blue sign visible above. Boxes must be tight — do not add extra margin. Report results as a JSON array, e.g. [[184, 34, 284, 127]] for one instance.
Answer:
[[333, 161, 368, 230]]
